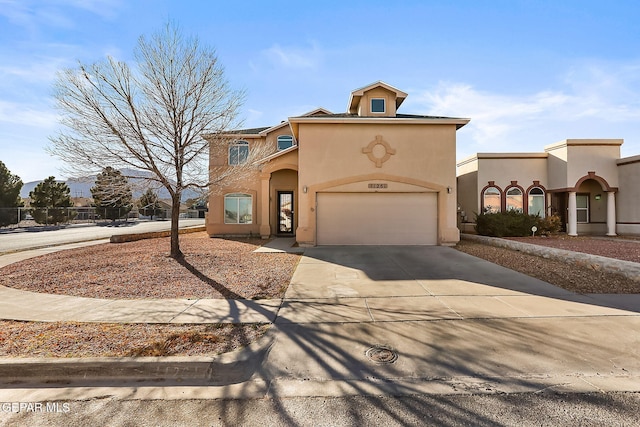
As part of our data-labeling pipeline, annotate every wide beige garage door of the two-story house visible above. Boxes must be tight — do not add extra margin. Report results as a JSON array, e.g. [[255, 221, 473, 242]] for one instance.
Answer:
[[316, 193, 438, 245]]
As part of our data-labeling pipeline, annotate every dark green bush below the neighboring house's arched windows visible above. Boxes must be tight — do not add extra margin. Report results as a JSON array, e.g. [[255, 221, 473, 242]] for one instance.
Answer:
[[476, 210, 540, 237]]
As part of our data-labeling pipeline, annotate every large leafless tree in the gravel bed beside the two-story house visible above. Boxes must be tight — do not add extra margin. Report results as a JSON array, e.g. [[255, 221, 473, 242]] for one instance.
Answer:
[[50, 24, 270, 258]]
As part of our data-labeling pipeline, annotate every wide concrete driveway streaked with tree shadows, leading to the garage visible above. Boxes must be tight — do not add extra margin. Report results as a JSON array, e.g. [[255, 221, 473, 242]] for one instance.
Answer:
[[254, 246, 640, 396]]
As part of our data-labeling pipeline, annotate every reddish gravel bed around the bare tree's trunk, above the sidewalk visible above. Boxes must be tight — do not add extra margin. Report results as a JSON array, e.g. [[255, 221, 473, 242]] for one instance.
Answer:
[[0, 232, 300, 299]]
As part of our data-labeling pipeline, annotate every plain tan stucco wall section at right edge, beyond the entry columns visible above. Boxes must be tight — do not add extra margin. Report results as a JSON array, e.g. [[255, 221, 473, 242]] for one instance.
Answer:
[[616, 156, 640, 234]]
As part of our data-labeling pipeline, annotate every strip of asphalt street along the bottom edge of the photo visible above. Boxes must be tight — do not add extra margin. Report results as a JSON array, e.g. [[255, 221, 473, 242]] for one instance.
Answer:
[[0, 392, 640, 427]]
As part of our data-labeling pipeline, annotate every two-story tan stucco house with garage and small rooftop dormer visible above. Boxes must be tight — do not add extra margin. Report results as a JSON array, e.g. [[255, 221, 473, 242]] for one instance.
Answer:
[[205, 82, 469, 246]]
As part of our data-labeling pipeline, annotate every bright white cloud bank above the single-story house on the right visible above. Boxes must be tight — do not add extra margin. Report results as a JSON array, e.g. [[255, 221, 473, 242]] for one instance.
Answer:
[[403, 63, 640, 157]]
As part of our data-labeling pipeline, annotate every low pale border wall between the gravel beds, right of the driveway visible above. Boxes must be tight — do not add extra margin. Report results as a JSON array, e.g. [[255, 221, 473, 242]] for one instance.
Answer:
[[460, 233, 640, 283]]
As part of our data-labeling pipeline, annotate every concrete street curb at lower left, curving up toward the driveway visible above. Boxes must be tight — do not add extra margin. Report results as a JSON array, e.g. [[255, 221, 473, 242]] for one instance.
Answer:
[[0, 327, 276, 388]]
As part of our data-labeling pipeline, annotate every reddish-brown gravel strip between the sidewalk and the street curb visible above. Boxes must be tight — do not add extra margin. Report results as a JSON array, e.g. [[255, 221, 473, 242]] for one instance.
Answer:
[[0, 321, 269, 358]]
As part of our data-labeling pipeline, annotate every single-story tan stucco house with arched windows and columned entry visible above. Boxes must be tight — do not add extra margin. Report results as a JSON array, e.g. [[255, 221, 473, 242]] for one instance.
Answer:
[[457, 139, 640, 236]]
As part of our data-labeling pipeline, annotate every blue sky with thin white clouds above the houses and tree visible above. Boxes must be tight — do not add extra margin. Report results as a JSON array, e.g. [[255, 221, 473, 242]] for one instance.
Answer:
[[0, 0, 640, 182]]
